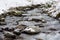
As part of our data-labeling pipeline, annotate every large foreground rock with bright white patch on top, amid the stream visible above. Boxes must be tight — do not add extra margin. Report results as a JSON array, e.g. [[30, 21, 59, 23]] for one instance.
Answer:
[[23, 26, 40, 34]]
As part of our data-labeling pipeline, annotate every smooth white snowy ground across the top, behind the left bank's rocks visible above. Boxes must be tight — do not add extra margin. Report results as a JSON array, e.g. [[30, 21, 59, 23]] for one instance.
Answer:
[[0, 0, 58, 14]]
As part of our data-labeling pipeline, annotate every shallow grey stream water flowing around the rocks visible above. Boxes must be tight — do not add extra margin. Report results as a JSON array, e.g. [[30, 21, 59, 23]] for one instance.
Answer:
[[0, 9, 60, 40]]
